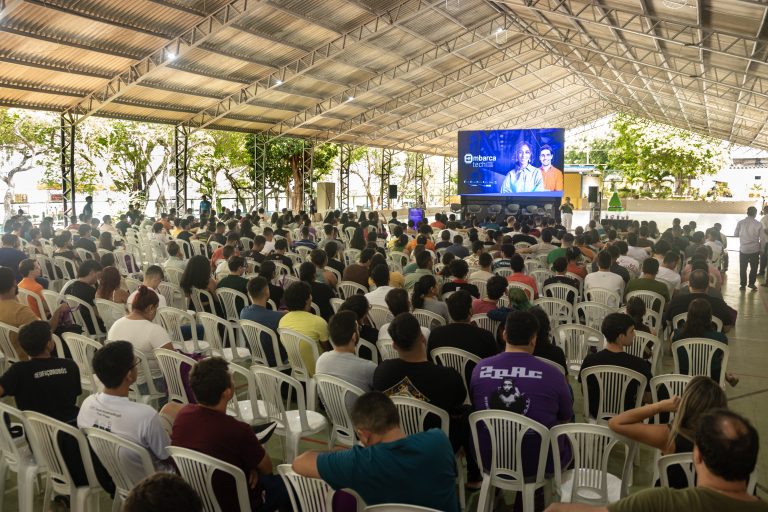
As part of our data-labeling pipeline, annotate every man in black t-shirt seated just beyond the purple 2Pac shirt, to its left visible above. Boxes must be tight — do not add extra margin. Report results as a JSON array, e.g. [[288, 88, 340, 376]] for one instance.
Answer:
[[427, 290, 499, 368]]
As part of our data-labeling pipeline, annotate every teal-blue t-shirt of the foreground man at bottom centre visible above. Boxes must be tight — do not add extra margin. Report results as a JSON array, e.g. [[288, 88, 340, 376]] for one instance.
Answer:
[[317, 429, 459, 512]]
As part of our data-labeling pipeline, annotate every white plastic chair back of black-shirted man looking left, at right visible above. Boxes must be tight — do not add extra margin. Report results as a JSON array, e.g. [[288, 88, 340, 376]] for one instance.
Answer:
[[581, 365, 648, 424]]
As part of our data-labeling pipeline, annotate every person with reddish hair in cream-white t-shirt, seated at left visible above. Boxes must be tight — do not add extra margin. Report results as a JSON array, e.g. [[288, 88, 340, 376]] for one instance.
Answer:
[[107, 285, 173, 394]]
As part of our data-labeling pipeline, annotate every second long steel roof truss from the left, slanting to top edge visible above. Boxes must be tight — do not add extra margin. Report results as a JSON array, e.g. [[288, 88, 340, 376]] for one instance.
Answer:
[[184, 0, 450, 132]]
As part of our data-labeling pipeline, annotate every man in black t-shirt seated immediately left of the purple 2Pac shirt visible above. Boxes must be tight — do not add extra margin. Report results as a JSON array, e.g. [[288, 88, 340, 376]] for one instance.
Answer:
[[373, 313, 482, 487]]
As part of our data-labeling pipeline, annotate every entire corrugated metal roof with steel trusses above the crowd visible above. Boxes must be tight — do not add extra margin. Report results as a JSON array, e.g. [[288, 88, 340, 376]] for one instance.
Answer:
[[0, 0, 768, 155]]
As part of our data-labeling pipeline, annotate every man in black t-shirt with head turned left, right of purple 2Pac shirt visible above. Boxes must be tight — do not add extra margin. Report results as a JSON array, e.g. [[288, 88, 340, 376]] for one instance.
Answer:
[[579, 313, 653, 418]]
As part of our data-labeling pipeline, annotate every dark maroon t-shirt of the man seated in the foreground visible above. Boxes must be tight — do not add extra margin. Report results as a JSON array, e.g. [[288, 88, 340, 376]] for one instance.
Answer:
[[171, 404, 266, 510]]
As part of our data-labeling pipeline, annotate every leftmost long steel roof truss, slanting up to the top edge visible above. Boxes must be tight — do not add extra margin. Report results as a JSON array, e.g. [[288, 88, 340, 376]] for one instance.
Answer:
[[61, 0, 261, 123]]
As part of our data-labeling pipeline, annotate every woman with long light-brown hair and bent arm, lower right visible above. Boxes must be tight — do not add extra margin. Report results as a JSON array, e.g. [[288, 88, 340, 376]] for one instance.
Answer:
[[608, 376, 728, 489]]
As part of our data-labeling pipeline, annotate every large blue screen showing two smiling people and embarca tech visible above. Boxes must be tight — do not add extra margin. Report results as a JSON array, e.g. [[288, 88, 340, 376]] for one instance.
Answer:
[[459, 129, 564, 194]]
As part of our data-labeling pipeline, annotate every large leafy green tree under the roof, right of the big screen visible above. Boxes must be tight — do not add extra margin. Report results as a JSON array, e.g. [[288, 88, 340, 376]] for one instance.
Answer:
[[607, 114, 728, 195]]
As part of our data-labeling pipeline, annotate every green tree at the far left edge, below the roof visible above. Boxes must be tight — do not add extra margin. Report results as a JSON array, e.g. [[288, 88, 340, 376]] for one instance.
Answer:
[[0, 108, 56, 219]]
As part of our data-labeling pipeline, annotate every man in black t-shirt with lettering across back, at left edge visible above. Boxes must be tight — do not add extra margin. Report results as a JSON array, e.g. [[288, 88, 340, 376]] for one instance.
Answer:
[[0, 320, 82, 423]]
